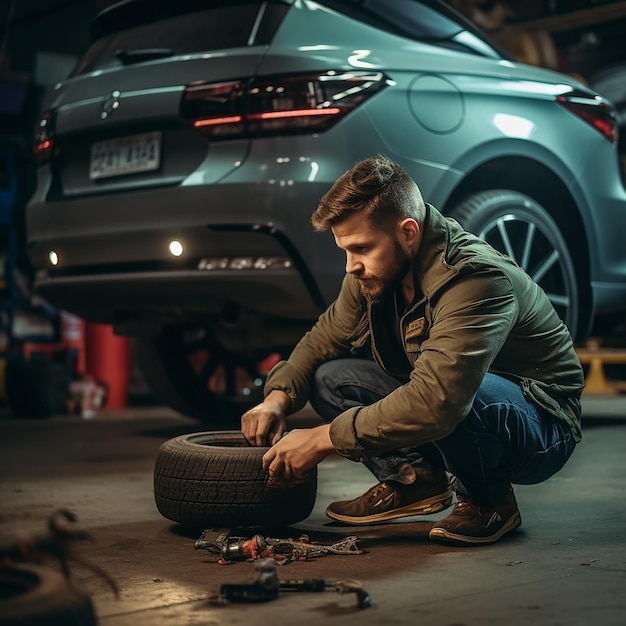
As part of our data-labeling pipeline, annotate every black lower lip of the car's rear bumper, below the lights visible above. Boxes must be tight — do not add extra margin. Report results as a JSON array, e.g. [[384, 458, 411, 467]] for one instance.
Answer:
[[35, 269, 321, 326]]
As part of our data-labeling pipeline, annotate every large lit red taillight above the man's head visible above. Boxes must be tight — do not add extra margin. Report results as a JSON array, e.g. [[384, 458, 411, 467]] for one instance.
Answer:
[[181, 71, 388, 141]]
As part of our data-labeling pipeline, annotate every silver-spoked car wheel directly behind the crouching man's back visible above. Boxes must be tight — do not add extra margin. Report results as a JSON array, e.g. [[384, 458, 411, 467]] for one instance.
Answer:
[[450, 190, 579, 337]]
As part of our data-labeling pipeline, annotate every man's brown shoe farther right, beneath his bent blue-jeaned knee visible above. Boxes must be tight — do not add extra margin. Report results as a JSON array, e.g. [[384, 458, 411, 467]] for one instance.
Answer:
[[428, 491, 522, 545]]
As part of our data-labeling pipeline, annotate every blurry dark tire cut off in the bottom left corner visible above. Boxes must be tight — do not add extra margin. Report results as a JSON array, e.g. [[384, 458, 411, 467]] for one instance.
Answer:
[[0, 564, 97, 626]]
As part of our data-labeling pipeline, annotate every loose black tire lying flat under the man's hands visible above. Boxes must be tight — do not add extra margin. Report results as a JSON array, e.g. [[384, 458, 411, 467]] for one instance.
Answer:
[[154, 431, 317, 528]]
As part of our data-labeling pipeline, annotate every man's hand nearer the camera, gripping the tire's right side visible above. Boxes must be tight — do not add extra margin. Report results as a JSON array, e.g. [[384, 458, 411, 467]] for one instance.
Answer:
[[263, 424, 335, 481]]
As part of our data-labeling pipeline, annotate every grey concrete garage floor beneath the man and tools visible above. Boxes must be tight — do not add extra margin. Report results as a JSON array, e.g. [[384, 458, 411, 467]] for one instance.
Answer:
[[0, 395, 626, 626]]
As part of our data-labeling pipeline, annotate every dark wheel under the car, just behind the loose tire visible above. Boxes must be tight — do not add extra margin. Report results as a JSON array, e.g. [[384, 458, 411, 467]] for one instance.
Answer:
[[133, 326, 280, 428]]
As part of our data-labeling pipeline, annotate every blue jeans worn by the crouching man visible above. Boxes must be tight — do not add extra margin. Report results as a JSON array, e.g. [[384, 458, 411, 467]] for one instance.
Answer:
[[311, 358, 576, 504]]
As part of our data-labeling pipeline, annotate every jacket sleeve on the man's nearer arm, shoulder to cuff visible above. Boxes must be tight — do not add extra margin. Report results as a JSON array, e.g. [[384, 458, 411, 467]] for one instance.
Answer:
[[330, 267, 518, 461]]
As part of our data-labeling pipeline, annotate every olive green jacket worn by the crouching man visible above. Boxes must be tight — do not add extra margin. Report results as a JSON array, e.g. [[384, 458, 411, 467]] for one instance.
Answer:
[[265, 205, 584, 461]]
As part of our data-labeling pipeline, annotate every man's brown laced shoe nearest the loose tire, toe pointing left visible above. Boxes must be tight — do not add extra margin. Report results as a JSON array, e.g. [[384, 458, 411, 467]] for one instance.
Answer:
[[326, 470, 452, 524]]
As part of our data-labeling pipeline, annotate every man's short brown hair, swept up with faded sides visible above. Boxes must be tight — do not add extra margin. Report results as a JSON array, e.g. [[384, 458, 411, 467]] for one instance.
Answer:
[[311, 155, 426, 231]]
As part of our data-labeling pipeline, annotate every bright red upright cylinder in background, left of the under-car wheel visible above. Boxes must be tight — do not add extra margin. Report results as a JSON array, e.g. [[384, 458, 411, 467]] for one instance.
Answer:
[[85, 322, 130, 409]]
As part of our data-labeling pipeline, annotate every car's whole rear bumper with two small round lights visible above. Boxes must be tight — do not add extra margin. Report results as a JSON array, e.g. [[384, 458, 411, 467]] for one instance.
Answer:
[[27, 166, 344, 323]]
